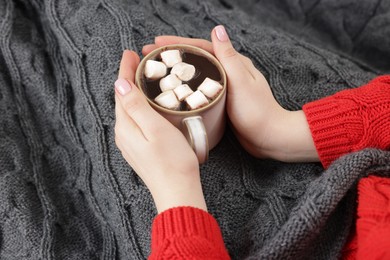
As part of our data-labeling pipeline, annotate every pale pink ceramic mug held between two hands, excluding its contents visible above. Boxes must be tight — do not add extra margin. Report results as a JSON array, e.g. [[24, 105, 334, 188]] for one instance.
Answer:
[[135, 44, 227, 163]]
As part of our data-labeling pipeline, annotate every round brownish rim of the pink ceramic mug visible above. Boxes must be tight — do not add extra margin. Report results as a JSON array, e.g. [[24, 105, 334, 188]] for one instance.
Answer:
[[135, 44, 227, 116]]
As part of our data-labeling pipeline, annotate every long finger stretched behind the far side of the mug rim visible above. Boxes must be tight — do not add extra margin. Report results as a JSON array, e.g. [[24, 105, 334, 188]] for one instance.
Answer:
[[154, 35, 214, 54]]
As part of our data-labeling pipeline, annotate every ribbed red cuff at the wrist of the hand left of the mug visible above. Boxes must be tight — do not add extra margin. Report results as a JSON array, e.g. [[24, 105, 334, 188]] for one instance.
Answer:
[[152, 206, 226, 251]]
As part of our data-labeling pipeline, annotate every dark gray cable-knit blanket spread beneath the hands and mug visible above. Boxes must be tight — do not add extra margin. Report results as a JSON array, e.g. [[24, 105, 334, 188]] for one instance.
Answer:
[[0, 0, 390, 259]]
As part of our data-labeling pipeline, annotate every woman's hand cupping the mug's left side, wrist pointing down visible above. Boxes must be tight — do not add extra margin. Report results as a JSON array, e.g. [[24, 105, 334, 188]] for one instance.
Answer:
[[115, 51, 207, 212]]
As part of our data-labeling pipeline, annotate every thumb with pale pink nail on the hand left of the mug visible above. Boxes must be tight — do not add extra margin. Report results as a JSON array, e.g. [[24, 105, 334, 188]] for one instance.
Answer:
[[115, 78, 166, 140]]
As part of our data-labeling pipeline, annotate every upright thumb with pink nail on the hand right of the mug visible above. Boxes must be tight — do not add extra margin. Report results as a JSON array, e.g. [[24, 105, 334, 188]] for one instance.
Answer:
[[211, 25, 252, 91]]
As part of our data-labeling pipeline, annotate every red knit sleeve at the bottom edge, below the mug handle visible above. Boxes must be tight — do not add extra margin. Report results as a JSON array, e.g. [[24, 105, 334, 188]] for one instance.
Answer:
[[149, 207, 230, 260]]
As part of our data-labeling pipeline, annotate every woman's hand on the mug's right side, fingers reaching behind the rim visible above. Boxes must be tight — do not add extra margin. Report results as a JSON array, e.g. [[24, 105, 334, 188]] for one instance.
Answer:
[[142, 25, 318, 162]]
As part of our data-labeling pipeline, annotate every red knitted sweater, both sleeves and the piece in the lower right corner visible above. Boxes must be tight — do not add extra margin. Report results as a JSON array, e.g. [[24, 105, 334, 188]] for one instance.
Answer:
[[149, 76, 390, 259]]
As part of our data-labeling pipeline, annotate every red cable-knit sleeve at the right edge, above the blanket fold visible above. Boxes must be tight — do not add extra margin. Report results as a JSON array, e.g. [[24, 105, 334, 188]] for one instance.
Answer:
[[303, 75, 390, 167]]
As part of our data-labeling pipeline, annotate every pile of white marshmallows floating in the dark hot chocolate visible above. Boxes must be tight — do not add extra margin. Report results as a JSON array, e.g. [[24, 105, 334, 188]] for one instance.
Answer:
[[144, 50, 223, 110]]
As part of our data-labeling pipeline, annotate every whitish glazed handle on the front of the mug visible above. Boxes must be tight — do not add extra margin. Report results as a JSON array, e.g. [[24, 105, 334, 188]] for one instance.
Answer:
[[182, 116, 209, 164]]
